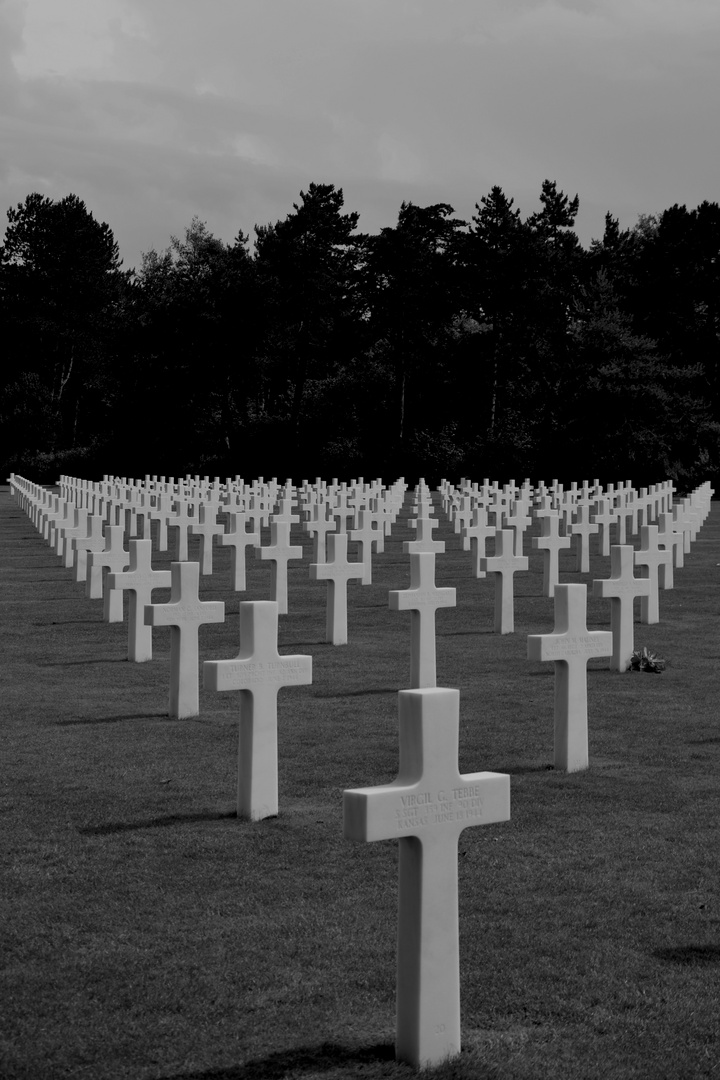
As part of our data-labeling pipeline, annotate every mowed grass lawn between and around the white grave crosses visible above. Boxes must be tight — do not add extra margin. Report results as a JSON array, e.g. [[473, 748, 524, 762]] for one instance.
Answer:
[[0, 487, 720, 1080]]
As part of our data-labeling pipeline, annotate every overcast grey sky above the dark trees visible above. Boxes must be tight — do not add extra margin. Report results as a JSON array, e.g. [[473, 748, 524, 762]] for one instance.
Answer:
[[0, 0, 720, 267]]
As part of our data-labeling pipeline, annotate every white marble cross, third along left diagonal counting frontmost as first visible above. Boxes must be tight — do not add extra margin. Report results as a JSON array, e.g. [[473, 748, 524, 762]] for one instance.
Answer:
[[145, 563, 225, 720]]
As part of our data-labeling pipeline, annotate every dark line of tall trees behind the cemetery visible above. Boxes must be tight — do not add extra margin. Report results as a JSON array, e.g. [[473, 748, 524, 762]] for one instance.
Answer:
[[0, 180, 720, 488]]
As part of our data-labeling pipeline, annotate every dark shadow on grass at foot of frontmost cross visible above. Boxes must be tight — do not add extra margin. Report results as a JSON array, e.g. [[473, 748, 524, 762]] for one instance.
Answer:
[[162, 1042, 397, 1080]]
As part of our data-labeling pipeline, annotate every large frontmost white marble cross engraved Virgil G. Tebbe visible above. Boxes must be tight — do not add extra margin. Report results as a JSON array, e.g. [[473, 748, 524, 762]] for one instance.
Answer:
[[343, 688, 510, 1068]]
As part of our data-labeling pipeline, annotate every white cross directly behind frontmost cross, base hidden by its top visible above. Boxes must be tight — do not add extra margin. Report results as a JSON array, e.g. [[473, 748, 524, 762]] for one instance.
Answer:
[[388, 552, 457, 687]]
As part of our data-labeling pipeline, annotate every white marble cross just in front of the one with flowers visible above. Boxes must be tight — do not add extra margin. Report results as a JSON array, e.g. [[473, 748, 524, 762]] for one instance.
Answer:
[[528, 584, 612, 772]]
